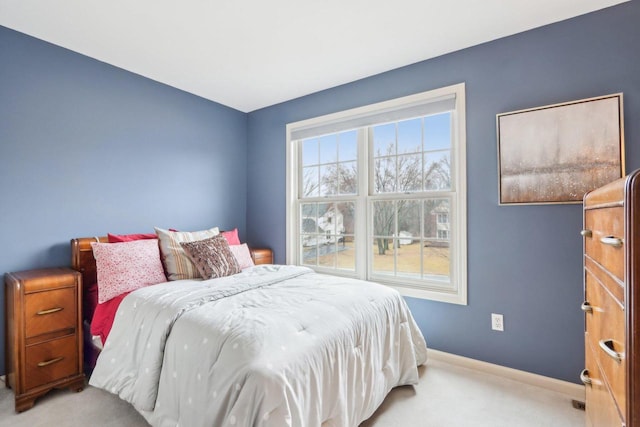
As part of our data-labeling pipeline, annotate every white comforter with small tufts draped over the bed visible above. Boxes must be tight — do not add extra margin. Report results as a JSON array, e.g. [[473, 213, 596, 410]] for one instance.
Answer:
[[90, 266, 426, 427]]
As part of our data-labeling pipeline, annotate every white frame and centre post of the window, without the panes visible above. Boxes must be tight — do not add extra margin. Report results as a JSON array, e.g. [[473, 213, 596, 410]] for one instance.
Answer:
[[286, 83, 467, 305]]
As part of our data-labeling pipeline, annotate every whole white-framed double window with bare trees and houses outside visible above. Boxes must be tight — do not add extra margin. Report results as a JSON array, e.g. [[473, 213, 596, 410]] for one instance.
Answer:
[[287, 84, 466, 304]]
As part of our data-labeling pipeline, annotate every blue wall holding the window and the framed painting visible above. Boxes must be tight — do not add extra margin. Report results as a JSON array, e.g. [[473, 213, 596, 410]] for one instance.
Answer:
[[247, 0, 640, 382]]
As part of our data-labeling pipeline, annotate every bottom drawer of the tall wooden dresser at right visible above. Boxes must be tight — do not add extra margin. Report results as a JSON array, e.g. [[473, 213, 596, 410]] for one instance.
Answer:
[[583, 339, 624, 427]]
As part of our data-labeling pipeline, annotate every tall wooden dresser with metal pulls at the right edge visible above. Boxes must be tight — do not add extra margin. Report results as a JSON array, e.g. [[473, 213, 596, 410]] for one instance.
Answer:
[[580, 171, 640, 427]]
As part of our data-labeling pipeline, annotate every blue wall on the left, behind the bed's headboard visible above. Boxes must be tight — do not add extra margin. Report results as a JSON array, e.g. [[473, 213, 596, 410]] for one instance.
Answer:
[[0, 27, 247, 374]]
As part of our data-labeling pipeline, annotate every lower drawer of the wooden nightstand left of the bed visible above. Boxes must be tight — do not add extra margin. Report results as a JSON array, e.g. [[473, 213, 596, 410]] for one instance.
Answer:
[[24, 335, 79, 390]]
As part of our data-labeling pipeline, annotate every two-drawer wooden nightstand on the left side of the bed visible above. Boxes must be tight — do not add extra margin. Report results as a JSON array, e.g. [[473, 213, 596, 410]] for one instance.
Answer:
[[5, 268, 85, 412]]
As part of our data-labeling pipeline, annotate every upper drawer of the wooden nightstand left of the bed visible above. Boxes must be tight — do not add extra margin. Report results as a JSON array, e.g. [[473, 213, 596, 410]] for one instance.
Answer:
[[25, 287, 78, 338]]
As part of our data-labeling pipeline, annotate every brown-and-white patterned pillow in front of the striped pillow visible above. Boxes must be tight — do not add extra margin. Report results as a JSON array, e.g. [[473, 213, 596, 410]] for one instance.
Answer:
[[180, 235, 241, 279]]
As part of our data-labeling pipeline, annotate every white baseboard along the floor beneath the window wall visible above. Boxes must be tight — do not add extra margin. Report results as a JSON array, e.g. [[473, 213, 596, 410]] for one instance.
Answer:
[[427, 349, 585, 402]]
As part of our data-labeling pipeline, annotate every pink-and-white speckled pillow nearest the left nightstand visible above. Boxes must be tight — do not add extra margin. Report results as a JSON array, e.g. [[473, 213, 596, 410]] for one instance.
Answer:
[[91, 240, 167, 304]]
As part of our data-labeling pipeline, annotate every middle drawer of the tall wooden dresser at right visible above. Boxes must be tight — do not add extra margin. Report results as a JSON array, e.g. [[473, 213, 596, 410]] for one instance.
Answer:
[[585, 272, 626, 413]]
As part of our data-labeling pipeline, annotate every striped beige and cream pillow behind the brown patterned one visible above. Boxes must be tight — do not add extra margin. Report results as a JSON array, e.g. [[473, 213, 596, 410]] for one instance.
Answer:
[[155, 227, 220, 280]]
